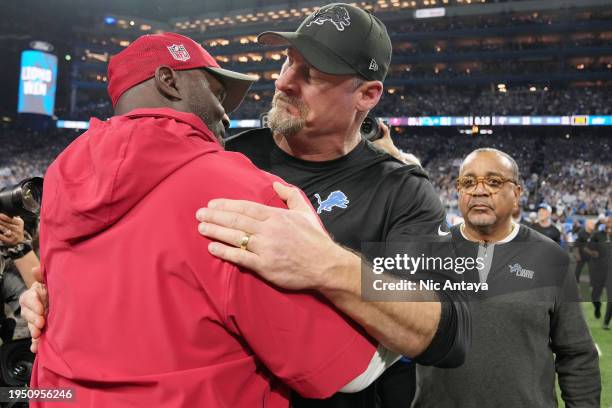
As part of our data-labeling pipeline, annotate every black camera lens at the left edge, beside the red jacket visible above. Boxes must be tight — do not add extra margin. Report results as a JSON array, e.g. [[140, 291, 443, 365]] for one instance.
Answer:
[[0, 177, 43, 217]]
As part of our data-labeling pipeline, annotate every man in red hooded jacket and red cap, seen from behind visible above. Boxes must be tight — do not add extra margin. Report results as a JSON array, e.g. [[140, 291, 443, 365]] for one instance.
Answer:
[[31, 33, 395, 408]]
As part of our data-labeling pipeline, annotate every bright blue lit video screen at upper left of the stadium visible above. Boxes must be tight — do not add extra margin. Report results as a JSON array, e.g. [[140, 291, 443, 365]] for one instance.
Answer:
[[17, 50, 57, 116]]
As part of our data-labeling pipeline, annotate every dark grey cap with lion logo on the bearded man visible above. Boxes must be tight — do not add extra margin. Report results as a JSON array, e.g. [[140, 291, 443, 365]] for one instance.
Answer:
[[257, 3, 392, 81]]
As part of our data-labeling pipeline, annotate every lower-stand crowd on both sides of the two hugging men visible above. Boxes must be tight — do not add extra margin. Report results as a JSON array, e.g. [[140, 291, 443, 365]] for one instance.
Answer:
[[0, 125, 612, 226]]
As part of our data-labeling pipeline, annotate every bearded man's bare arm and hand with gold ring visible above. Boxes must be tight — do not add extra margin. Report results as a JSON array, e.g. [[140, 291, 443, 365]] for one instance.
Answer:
[[197, 183, 441, 357]]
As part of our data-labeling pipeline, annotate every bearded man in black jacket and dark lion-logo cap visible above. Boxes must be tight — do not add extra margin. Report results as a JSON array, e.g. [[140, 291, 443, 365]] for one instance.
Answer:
[[198, 3, 469, 408]]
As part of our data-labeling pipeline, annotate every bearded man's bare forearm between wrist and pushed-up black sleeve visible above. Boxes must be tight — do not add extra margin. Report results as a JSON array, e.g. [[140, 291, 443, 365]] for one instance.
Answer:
[[319, 245, 441, 357]]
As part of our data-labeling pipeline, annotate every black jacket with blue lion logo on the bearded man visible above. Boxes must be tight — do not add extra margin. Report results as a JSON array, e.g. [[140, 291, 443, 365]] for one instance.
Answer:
[[226, 128, 471, 408]]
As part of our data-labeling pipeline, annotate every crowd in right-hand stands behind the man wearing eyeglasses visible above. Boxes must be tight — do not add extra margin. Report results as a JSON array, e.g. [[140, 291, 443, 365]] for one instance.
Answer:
[[394, 128, 612, 218]]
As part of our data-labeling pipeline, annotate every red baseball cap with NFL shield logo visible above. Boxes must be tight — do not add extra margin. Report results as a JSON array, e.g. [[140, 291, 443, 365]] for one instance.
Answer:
[[108, 33, 259, 113]]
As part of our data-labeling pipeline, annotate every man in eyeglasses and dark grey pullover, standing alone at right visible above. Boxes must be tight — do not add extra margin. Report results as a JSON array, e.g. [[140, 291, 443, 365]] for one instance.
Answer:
[[412, 149, 601, 408]]
